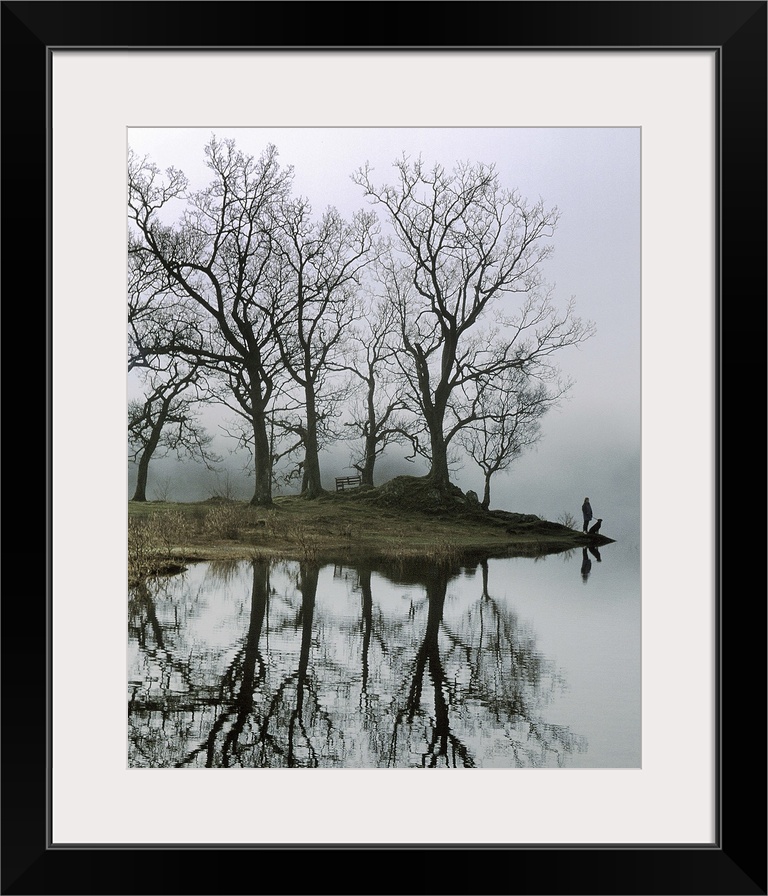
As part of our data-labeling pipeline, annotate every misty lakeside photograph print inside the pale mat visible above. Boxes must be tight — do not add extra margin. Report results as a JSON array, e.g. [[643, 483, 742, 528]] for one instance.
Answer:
[[126, 127, 643, 769]]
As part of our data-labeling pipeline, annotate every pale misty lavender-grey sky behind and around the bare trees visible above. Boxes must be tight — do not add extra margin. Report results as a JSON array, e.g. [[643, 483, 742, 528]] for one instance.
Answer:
[[128, 128, 641, 538]]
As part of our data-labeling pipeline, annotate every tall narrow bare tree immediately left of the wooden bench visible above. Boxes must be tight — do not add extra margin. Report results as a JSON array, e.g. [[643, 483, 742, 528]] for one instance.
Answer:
[[268, 199, 376, 498]]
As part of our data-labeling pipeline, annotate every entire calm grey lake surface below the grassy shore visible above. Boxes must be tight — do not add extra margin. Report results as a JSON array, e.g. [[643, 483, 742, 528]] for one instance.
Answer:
[[127, 544, 641, 769]]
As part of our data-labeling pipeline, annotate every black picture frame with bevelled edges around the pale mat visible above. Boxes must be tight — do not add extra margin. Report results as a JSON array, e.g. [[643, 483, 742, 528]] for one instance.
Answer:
[[0, 0, 768, 896]]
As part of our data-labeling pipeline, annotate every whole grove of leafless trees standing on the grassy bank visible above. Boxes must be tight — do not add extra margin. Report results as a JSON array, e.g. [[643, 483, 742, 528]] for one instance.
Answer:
[[128, 137, 594, 508]]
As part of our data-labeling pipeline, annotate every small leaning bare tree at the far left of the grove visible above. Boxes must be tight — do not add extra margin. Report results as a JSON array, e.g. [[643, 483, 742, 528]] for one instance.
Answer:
[[128, 359, 221, 501]]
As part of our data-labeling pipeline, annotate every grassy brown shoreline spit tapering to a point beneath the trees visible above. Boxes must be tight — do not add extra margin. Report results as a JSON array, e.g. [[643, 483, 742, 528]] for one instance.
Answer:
[[128, 477, 613, 579]]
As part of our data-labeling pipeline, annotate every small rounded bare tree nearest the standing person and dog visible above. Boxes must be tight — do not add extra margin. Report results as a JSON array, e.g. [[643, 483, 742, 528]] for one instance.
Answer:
[[459, 368, 570, 510]]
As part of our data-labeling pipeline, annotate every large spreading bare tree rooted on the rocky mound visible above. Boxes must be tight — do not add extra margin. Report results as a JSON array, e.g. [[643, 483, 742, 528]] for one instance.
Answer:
[[353, 156, 593, 490]]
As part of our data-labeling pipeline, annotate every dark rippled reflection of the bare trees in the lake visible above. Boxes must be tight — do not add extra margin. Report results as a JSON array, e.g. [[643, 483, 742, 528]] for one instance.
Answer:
[[128, 560, 586, 768]]
